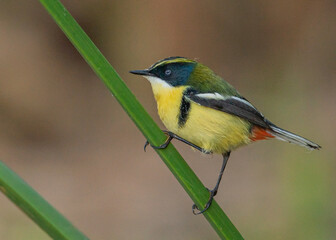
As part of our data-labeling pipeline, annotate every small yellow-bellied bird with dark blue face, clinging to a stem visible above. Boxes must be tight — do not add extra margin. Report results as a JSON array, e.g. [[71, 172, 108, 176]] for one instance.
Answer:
[[130, 56, 321, 215]]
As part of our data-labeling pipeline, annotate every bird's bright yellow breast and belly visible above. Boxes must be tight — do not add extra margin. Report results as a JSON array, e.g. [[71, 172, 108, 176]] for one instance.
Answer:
[[152, 83, 251, 153]]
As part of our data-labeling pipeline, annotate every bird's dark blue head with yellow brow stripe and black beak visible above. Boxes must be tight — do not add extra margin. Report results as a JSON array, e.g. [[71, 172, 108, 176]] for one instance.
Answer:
[[130, 57, 198, 87]]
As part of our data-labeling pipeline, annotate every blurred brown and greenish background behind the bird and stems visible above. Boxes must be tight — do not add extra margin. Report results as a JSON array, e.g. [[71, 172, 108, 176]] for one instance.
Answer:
[[0, 0, 336, 240]]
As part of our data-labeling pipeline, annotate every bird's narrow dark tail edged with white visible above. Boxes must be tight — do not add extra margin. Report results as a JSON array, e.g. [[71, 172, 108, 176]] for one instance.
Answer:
[[268, 124, 321, 150]]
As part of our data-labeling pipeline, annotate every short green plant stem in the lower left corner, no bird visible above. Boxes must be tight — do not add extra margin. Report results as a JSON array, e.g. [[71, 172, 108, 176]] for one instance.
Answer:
[[0, 161, 88, 240]]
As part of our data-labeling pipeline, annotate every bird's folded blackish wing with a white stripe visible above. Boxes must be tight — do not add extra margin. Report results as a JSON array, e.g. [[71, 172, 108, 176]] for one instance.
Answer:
[[185, 91, 270, 128]]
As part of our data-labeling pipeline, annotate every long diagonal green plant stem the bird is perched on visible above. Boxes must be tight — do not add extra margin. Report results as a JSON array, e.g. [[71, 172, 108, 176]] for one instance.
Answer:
[[36, 0, 243, 239]]
